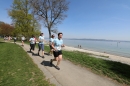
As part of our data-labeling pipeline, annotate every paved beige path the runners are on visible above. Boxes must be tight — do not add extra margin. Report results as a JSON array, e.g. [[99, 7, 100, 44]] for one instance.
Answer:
[[17, 43, 121, 86]]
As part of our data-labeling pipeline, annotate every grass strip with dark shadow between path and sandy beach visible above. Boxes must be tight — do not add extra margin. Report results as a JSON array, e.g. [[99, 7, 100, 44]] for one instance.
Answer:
[[45, 46, 130, 85]]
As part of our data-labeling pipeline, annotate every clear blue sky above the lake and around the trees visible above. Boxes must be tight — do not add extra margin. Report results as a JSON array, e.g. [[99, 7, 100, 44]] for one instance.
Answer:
[[0, 0, 130, 41]]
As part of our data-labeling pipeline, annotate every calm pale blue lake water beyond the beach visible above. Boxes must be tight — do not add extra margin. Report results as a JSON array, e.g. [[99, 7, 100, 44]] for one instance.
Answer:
[[45, 39, 130, 58]]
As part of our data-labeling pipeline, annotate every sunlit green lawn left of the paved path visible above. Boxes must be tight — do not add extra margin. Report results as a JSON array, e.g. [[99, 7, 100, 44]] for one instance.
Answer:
[[0, 42, 53, 86]]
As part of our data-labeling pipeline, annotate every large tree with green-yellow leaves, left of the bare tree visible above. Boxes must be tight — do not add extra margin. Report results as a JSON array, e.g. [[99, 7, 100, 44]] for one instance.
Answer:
[[9, 0, 40, 37]]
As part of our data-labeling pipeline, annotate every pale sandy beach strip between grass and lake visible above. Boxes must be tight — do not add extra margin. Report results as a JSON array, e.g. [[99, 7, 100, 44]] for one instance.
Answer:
[[62, 46, 130, 65]]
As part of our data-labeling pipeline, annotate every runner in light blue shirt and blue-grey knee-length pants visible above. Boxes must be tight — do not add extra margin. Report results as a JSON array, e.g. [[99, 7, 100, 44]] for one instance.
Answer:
[[38, 33, 44, 58]]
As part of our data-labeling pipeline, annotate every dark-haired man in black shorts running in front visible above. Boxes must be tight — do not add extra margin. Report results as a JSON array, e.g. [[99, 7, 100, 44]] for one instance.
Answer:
[[50, 33, 65, 70]]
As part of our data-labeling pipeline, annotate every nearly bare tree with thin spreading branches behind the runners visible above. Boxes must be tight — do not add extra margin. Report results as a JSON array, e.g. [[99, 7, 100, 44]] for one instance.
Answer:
[[29, 0, 69, 37]]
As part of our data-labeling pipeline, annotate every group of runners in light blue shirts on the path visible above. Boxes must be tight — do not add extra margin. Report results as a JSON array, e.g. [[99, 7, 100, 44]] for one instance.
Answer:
[[28, 33, 64, 70]]
